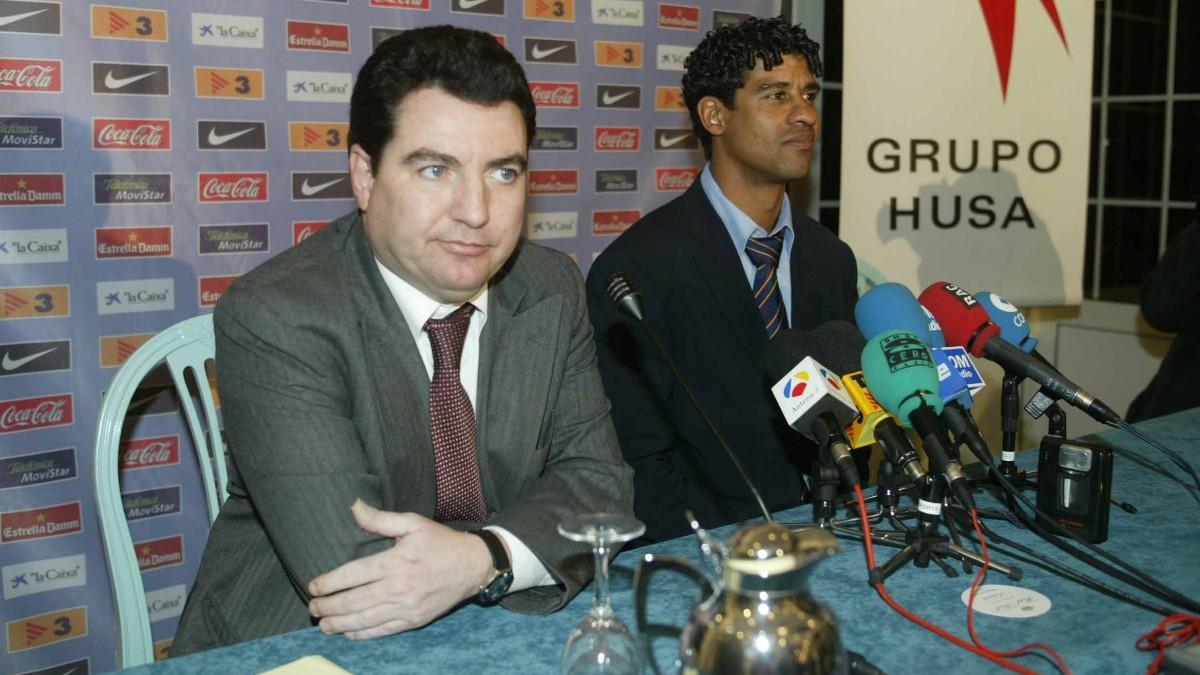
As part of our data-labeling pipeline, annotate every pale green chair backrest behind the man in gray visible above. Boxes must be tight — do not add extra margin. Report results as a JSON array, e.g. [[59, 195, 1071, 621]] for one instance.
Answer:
[[94, 315, 228, 668]]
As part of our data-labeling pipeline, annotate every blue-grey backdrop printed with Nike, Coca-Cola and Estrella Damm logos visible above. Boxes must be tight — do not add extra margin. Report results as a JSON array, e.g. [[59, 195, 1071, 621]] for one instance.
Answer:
[[0, 0, 777, 674]]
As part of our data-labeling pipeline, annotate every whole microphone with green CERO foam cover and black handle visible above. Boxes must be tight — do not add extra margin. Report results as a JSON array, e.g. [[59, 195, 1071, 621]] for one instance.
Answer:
[[863, 330, 974, 508]]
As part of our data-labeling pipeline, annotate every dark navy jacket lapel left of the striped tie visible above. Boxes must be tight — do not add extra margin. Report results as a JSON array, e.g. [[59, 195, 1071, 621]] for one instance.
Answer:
[[684, 180, 767, 359]]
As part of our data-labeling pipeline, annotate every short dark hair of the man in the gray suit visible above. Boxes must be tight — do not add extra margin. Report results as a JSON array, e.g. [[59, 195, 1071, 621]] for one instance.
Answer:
[[347, 25, 536, 171]]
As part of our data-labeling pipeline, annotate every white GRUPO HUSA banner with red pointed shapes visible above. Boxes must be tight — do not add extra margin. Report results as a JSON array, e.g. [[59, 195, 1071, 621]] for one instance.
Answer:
[[840, 0, 1094, 306]]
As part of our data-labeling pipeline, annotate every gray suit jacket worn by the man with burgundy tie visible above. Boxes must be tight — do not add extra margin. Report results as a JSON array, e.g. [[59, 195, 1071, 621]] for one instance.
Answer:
[[173, 213, 631, 653]]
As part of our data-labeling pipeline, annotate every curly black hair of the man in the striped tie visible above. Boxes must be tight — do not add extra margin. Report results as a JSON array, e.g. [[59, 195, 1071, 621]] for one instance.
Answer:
[[683, 17, 821, 157]]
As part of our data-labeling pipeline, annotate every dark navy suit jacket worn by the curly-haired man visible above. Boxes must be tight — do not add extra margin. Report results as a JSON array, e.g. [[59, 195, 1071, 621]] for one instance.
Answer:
[[588, 180, 858, 540]]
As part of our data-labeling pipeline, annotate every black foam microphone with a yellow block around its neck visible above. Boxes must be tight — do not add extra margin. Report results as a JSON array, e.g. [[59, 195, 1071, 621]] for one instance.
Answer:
[[812, 321, 925, 484]]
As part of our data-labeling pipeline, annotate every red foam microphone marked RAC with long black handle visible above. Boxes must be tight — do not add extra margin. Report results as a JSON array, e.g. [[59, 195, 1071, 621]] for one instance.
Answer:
[[920, 281, 1121, 426]]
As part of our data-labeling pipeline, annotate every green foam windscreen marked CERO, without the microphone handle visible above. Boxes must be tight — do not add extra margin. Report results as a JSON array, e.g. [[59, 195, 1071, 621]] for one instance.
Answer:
[[863, 330, 942, 426]]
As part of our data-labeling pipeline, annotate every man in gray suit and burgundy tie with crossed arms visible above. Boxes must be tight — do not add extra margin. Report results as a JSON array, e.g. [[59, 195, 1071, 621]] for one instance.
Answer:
[[173, 26, 632, 653]]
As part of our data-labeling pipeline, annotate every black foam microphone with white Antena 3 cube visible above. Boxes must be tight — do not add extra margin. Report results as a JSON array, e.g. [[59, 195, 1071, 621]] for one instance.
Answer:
[[766, 329, 862, 485]]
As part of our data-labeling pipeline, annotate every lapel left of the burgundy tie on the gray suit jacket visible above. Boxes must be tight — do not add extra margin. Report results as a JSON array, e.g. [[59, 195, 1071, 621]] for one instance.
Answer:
[[346, 217, 437, 515]]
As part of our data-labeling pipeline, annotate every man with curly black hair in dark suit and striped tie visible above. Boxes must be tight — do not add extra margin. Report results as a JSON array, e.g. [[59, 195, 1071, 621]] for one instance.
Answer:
[[588, 18, 857, 540]]
